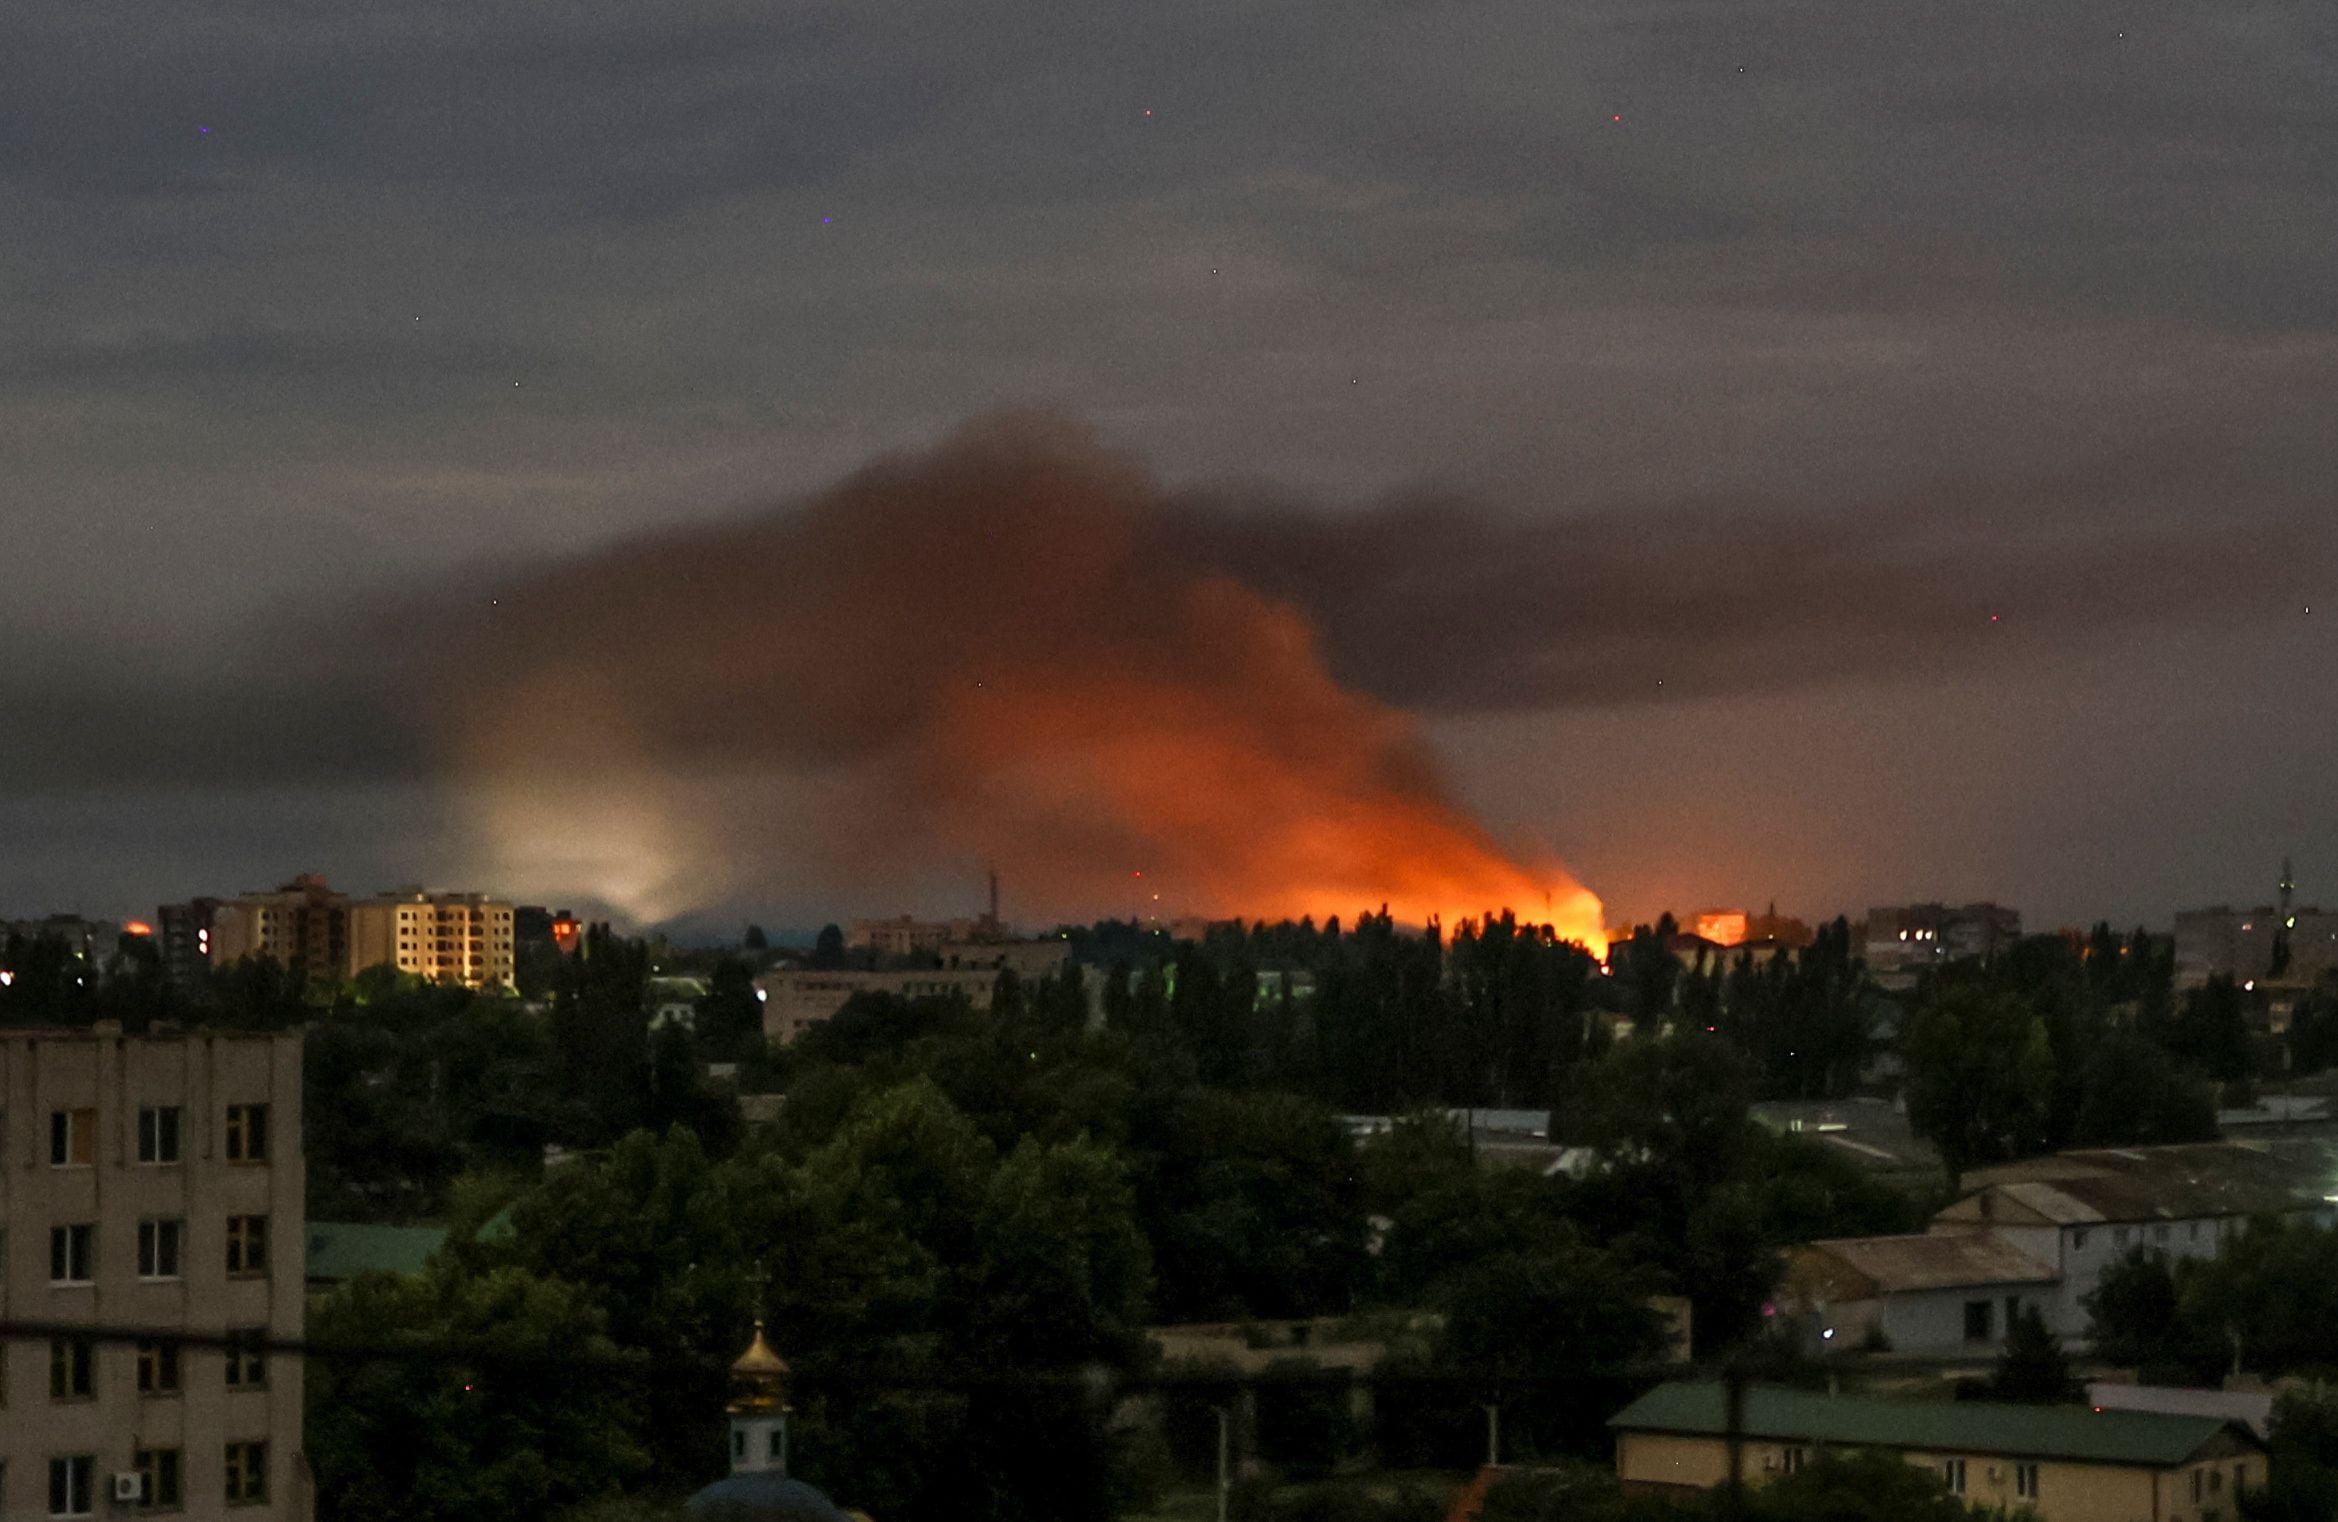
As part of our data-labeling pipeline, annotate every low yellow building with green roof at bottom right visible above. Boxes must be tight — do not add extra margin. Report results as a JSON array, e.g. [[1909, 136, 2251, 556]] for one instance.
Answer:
[[1609, 1384, 2266, 1522]]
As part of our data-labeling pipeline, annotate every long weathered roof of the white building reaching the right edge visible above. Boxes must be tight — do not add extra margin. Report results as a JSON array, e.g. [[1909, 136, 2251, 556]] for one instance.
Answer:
[[1966, 1139, 2338, 1225]]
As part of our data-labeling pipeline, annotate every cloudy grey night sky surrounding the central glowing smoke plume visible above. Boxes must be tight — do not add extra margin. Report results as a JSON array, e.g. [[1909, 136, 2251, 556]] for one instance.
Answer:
[[0, 0, 2338, 926]]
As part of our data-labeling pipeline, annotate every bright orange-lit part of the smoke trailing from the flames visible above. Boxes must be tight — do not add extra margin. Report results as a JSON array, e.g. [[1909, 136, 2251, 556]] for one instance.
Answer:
[[933, 582, 1606, 954]]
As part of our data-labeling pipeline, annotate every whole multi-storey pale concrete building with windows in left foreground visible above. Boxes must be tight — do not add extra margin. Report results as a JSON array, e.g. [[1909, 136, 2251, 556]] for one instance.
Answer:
[[0, 1026, 311, 1522]]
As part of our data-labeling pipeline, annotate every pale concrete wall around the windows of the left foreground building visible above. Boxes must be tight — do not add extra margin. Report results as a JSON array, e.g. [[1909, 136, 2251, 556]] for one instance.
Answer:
[[0, 1029, 309, 1522]]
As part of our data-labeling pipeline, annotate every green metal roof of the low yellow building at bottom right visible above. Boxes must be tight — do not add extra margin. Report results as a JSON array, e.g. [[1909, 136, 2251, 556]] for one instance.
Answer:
[[1609, 1382, 2263, 1468]]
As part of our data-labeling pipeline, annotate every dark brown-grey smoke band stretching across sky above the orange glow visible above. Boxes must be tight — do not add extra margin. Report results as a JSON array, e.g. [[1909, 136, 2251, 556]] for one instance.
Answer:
[[0, 418, 2333, 786]]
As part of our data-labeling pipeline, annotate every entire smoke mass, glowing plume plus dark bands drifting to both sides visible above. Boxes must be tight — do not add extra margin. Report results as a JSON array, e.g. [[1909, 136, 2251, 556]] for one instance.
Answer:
[[0, 416, 2329, 921]]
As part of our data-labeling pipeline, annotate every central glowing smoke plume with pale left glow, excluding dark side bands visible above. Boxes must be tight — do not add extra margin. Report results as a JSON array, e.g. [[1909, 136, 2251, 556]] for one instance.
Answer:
[[421, 418, 1602, 942]]
